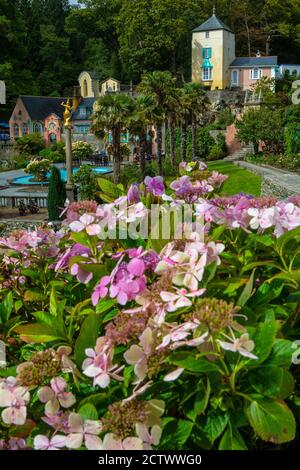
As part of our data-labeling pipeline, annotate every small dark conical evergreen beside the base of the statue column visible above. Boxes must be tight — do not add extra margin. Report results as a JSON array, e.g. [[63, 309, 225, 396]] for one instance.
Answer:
[[47, 166, 66, 221]]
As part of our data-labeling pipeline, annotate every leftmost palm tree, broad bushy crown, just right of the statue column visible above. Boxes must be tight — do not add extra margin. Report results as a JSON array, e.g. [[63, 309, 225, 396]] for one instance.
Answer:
[[93, 93, 134, 183]]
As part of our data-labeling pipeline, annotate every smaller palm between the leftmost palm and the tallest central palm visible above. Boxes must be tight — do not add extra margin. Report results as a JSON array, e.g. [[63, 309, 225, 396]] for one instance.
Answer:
[[127, 94, 156, 179]]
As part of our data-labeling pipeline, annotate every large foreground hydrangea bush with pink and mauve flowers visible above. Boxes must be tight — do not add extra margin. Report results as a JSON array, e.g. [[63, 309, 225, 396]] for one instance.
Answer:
[[0, 162, 300, 450]]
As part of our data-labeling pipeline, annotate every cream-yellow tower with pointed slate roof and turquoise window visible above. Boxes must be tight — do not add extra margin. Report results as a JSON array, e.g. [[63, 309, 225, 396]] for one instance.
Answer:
[[192, 10, 235, 90]]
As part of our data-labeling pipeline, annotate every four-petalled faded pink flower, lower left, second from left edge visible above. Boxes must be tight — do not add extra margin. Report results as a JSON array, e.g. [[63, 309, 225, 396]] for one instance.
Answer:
[[38, 377, 76, 414]]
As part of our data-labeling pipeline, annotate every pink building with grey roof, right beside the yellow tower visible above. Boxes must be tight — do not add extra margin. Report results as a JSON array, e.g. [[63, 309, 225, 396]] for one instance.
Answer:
[[229, 53, 278, 90]]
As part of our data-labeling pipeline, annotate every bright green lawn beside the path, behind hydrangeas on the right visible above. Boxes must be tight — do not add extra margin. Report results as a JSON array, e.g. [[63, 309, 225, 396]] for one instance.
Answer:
[[208, 161, 262, 196]]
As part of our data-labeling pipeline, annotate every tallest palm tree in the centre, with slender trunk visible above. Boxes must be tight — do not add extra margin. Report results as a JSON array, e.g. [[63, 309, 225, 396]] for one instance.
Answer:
[[138, 71, 175, 175]]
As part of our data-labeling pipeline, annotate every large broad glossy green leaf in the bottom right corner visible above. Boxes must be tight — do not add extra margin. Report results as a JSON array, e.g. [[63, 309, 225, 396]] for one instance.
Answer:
[[246, 398, 296, 444]]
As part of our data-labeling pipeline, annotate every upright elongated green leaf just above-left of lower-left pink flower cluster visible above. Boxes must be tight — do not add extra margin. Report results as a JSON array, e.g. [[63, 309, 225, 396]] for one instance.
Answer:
[[74, 313, 100, 368]]
